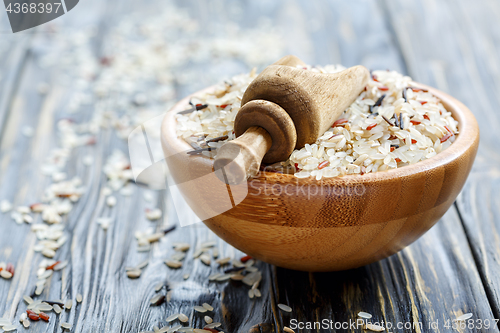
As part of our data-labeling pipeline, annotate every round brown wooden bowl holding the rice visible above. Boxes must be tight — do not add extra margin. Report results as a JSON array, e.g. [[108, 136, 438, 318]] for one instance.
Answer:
[[162, 83, 479, 271]]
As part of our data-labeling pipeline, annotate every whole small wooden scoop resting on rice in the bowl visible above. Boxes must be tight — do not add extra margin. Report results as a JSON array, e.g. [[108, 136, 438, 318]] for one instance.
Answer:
[[214, 55, 370, 184]]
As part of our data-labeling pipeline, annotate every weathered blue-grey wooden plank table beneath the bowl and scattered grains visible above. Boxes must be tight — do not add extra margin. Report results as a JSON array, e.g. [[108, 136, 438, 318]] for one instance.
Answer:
[[0, 0, 500, 332]]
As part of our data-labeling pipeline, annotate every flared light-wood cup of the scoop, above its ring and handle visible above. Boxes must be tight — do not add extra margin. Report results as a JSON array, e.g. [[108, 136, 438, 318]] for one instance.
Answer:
[[241, 65, 370, 148]]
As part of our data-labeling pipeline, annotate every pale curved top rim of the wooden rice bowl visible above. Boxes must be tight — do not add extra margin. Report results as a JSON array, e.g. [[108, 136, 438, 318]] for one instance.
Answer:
[[161, 82, 479, 185]]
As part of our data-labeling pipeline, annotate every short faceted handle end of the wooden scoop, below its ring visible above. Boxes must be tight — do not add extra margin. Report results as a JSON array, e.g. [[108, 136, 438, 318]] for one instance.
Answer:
[[214, 126, 272, 185]]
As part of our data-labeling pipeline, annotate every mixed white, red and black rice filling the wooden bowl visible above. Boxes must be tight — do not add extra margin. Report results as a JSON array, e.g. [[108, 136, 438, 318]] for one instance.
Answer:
[[177, 65, 458, 180]]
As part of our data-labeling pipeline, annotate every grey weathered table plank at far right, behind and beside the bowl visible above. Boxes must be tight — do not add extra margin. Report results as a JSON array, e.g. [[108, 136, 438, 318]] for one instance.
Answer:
[[387, 1, 500, 318]]
